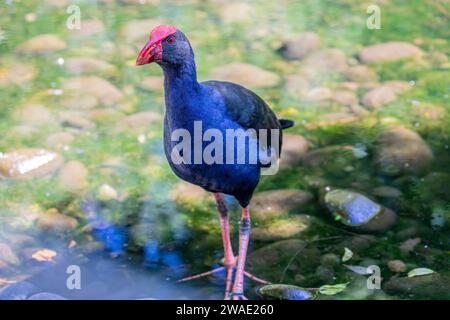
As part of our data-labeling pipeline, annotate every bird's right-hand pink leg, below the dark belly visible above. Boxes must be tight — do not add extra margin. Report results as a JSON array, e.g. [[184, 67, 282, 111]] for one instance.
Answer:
[[232, 207, 251, 300]]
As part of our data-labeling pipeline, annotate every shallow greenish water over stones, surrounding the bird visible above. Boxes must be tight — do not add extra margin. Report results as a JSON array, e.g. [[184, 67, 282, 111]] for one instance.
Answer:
[[0, 0, 450, 299]]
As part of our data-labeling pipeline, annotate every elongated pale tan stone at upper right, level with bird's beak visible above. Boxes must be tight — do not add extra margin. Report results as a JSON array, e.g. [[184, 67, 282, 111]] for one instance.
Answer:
[[359, 42, 423, 63]]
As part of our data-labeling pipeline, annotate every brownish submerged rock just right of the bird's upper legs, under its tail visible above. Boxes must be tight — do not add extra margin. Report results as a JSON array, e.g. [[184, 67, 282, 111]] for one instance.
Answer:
[[252, 189, 313, 221]]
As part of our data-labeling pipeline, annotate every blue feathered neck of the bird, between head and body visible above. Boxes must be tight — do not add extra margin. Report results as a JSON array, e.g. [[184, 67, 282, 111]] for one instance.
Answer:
[[163, 61, 200, 105]]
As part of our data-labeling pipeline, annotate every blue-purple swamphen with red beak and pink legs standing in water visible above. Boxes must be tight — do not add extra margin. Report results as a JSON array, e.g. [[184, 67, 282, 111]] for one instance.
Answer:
[[136, 25, 293, 300]]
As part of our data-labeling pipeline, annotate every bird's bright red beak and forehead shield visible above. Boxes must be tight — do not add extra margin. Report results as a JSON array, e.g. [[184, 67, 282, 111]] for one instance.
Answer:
[[136, 25, 177, 66]]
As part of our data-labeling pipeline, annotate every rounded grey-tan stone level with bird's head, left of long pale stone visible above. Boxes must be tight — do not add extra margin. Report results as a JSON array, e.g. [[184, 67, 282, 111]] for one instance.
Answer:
[[279, 32, 320, 59]]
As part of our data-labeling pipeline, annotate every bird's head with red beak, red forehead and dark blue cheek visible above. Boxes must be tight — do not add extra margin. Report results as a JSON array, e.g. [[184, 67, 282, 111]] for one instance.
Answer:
[[136, 25, 193, 66]]
